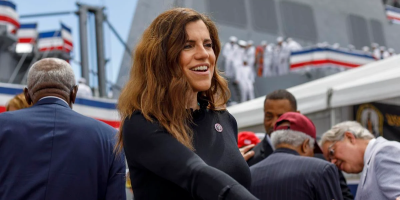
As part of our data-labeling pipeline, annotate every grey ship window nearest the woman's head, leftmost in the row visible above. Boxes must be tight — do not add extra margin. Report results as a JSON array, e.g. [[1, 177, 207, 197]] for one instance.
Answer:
[[207, 0, 247, 28]]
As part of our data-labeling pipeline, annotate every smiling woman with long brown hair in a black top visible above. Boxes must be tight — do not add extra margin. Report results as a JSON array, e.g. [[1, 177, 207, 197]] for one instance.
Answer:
[[116, 8, 256, 200]]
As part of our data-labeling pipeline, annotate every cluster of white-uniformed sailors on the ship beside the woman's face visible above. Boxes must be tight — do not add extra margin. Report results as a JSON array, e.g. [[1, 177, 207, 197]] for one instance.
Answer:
[[222, 36, 302, 102]]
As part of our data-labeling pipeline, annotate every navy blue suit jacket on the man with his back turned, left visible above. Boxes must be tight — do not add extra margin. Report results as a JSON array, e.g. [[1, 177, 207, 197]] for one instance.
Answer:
[[0, 97, 126, 200]]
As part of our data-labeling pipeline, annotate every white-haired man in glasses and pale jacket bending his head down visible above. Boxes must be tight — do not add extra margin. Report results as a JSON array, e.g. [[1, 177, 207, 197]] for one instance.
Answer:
[[320, 121, 400, 200]]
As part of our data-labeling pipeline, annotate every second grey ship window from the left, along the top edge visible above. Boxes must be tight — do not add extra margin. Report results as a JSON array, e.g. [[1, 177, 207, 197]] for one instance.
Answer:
[[250, 0, 278, 34]]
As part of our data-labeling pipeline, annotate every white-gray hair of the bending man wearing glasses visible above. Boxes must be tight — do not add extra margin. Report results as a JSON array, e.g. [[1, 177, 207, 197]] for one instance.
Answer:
[[320, 121, 375, 146]]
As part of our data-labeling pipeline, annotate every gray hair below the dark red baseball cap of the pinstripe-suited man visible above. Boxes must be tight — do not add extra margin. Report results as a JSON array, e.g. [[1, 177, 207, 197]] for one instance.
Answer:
[[271, 129, 315, 148]]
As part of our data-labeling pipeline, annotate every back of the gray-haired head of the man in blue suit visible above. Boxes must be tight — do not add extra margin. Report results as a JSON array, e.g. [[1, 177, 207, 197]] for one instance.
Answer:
[[27, 58, 75, 101]]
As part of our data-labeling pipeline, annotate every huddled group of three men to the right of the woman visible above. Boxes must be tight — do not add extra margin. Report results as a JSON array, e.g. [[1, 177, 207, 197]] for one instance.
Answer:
[[241, 90, 400, 200]]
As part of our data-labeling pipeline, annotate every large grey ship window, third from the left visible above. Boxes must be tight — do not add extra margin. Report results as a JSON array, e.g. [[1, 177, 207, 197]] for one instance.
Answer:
[[279, 1, 317, 42]]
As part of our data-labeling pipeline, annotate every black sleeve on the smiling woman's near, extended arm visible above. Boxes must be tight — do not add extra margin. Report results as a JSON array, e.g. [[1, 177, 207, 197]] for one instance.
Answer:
[[123, 112, 257, 200]]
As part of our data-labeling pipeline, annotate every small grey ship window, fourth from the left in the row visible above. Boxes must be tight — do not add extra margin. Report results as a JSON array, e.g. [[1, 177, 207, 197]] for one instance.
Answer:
[[347, 15, 371, 49]]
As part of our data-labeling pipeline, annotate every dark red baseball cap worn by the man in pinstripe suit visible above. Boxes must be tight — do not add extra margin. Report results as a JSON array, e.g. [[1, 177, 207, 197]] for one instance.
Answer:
[[274, 112, 322, 153]]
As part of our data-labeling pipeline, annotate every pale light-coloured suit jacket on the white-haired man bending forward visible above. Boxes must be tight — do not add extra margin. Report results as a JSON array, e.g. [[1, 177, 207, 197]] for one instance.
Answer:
[[356, 137, 400, 200]]
